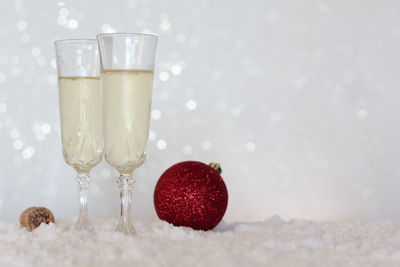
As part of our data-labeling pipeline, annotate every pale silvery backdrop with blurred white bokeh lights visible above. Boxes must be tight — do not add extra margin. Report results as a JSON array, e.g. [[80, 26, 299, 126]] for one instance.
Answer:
[[0, 0, 400, 221]]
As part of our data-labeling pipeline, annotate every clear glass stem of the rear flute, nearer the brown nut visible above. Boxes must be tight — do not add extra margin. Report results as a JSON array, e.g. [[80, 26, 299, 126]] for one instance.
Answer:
[[76, 173, 91, 230]]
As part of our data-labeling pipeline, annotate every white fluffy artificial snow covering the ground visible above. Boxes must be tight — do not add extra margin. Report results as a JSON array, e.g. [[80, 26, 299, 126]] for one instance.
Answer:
[[0, 216, 400, 267]]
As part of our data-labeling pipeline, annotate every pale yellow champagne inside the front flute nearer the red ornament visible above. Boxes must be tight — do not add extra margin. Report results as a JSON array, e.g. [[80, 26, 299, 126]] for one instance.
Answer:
[[101, 70, 153, 173]]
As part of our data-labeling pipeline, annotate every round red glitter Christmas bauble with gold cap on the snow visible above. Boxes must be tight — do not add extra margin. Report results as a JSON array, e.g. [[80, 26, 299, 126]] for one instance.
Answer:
[[154, 161, 228, 230]]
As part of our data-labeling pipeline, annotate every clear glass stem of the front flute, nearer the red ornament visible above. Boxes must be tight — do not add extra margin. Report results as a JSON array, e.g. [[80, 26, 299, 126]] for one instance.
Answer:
[[117, 174, 135, 234]]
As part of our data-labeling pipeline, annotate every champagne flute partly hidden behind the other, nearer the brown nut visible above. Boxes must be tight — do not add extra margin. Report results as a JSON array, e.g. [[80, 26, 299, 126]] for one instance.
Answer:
[[55, 39, 103, 231]]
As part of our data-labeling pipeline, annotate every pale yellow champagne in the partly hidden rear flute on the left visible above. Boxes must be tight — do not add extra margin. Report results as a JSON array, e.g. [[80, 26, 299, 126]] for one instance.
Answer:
[[58, 77, 103, 172]]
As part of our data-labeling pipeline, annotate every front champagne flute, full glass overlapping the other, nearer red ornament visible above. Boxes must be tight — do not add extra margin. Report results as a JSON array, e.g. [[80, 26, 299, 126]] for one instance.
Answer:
[[97, 33, 158, 234]]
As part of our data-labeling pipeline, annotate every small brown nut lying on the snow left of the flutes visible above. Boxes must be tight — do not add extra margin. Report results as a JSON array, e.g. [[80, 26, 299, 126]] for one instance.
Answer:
[[19, 207, 54, 231]]
